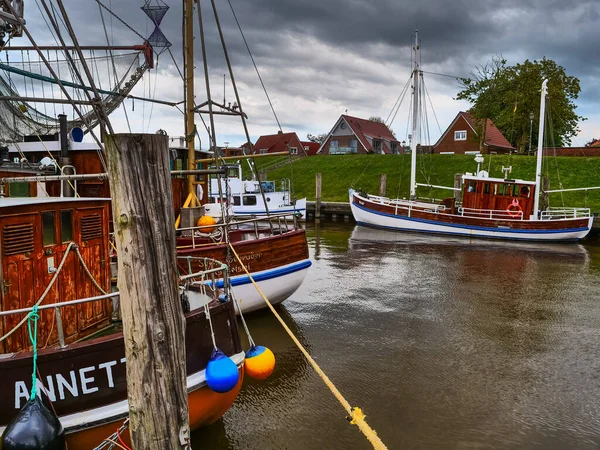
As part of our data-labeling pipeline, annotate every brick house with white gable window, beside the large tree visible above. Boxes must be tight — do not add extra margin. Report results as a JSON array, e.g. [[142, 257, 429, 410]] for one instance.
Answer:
[[433, 111, 516, 154]]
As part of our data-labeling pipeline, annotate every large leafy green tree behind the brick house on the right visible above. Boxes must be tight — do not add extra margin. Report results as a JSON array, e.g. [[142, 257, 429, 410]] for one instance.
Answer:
[[456, 56, 586, 151]]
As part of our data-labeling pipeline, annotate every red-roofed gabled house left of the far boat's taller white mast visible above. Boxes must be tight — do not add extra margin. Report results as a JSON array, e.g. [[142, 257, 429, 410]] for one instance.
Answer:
[[317, 114, 402, 155]]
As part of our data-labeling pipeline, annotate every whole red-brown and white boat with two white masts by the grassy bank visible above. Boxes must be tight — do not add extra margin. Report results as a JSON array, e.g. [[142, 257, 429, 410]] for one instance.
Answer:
[[349, 36, 593, 241]]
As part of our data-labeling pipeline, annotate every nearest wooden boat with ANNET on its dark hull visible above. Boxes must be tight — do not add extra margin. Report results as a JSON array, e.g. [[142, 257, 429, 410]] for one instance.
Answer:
[[0, 197, 244, 449]]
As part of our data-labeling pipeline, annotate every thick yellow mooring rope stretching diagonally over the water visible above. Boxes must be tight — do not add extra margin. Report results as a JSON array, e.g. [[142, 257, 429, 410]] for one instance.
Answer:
[[229, 242, 387, 450]]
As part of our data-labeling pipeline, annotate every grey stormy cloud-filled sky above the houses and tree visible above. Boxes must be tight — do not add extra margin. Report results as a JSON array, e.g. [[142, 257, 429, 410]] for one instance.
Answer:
[[25, 0, 600, 141]]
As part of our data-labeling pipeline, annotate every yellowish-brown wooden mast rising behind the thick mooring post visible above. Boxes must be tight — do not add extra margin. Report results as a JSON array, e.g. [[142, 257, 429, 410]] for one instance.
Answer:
[[183, 0, 202, 208]]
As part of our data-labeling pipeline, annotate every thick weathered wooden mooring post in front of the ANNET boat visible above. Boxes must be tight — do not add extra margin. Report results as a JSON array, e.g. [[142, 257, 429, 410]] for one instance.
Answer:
[[105, 134, 189, 450]]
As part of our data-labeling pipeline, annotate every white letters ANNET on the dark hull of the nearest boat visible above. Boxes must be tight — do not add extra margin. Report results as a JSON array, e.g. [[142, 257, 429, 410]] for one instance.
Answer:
[[15, 358, 125, 409]]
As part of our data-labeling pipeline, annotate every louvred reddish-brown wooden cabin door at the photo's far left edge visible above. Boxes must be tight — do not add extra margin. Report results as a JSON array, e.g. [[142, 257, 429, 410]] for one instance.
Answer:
[[0, 214, 39, 353]]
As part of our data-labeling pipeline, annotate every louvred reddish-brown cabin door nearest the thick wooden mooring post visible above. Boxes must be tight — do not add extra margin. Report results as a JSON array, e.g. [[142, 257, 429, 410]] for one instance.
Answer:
[[73, 208, 110, 331]]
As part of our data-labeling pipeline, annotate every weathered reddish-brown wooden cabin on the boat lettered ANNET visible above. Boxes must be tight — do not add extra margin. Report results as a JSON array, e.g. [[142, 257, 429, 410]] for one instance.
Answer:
[[0, 197, 111, 353]]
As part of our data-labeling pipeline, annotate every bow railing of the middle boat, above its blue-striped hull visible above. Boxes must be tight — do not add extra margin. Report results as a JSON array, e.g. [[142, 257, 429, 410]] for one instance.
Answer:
[[177, 213, 298, 249]]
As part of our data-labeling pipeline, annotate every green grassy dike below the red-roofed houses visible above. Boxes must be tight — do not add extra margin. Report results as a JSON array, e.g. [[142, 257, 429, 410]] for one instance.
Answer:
[[253, 155, 600, 212]]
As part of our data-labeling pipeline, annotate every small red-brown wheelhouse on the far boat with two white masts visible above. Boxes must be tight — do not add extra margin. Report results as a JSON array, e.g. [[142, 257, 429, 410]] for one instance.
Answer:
[[462, 175, 536, 220]]
